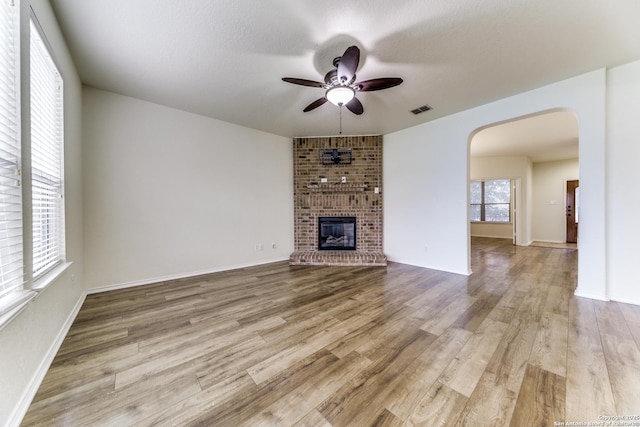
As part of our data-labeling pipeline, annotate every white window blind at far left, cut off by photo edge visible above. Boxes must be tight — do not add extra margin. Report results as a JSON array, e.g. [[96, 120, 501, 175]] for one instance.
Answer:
[[0, 0, 24, 300]]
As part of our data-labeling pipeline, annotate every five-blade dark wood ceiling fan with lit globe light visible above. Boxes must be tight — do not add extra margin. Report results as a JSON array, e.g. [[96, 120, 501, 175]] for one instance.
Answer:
[[282, 46, 402, 114]]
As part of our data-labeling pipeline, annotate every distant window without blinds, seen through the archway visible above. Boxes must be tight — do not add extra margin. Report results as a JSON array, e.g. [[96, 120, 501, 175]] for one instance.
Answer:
[[469, 179, 511, 222]]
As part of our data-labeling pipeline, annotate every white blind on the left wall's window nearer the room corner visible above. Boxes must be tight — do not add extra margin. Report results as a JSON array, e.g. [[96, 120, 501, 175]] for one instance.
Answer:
[[30, 21, 65, 280]]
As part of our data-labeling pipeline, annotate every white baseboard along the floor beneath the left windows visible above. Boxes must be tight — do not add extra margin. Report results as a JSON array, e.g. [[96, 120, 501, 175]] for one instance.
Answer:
[[5, 292, 87, 427]]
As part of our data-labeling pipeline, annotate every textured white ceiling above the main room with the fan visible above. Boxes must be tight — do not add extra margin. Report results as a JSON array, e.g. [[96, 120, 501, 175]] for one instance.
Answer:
[[51, 0, 640, 144]]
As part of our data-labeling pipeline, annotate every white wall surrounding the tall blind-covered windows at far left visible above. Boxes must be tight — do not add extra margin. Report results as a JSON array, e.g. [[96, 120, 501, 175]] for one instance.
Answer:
[[0, 0, 84, 425]]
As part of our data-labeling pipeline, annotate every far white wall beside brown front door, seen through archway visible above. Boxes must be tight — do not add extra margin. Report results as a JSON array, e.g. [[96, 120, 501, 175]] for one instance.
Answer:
[[532, 159, 579, 243]]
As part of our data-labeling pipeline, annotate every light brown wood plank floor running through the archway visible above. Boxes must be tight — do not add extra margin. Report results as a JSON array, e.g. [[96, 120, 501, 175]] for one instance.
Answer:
[[23, 238, 640, 426]]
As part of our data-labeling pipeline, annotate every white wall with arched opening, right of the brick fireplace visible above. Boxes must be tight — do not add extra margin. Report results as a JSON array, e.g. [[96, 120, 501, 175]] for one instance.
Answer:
[[383, 69, 607, 299]]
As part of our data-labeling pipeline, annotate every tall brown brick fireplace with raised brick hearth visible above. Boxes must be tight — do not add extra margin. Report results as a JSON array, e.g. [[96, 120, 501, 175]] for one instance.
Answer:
[[289, 135, 387, 266]]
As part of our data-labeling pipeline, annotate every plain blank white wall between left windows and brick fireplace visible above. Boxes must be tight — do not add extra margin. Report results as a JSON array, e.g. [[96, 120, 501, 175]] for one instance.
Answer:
[[83, 87, 293, 290]]
